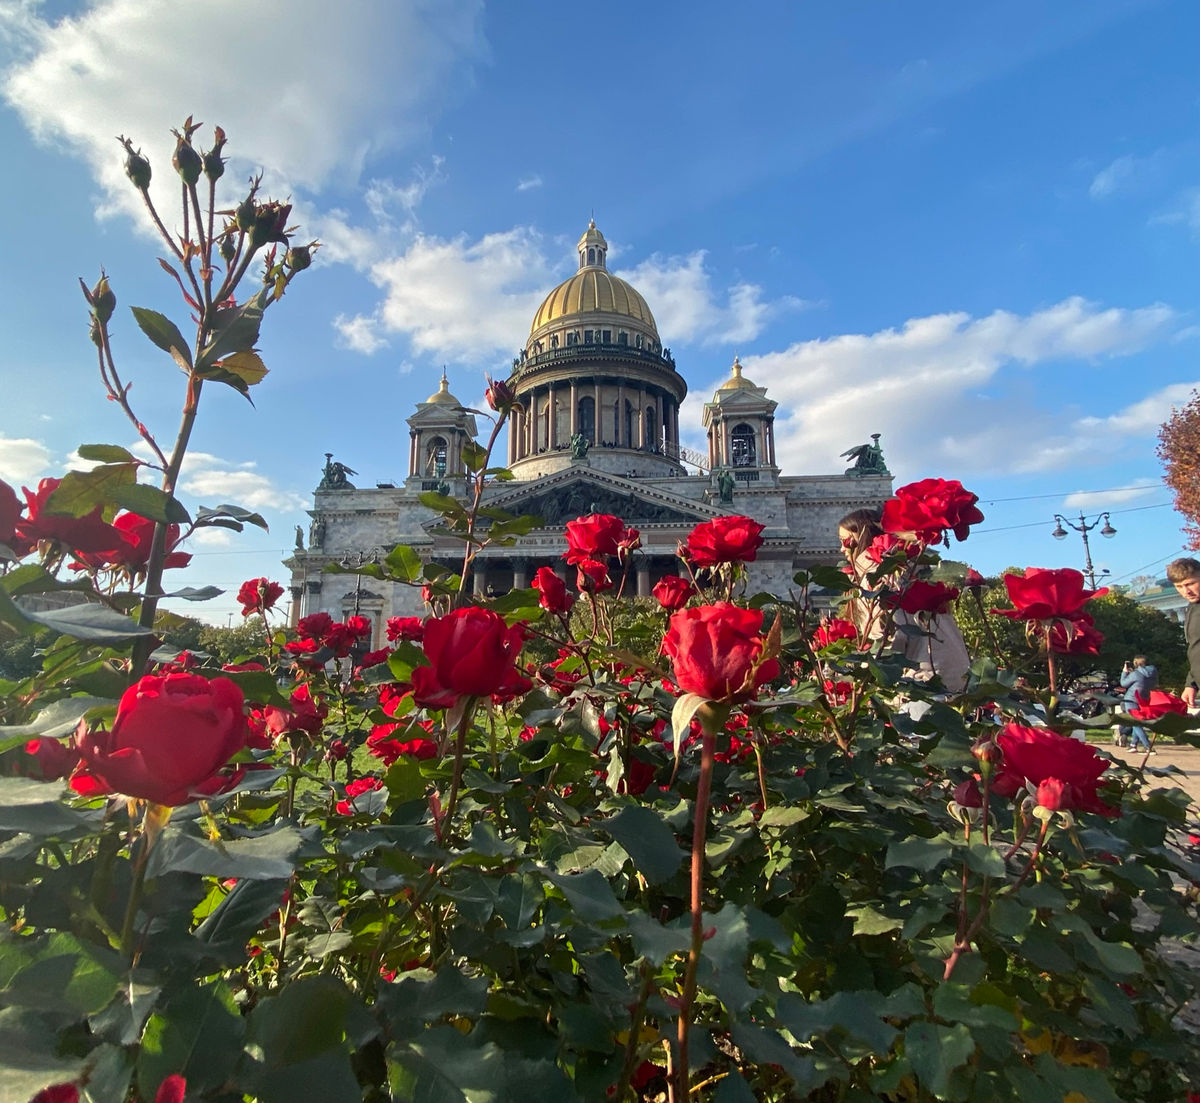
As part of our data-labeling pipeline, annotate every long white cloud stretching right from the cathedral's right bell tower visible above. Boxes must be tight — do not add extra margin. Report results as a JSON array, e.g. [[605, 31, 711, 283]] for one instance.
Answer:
[[680, 298, 1192, 480]]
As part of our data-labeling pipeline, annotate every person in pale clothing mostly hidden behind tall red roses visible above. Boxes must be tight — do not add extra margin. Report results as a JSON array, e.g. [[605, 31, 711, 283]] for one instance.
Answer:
[[838, 509, 971, 694]]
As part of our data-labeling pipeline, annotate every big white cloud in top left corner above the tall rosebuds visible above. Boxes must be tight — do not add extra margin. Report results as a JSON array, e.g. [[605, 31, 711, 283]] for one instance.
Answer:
[[0, 0, 486, 218]]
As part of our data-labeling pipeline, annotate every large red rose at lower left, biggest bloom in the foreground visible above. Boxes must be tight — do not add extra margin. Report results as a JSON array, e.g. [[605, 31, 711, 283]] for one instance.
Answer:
[[71, 675, 246, 804]]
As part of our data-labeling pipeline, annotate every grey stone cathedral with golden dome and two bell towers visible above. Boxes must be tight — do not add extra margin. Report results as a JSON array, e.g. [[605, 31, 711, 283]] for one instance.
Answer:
[[284, 221, 892, 647]]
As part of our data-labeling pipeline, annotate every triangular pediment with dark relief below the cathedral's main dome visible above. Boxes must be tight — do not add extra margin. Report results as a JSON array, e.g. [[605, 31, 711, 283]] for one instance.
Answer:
[[486, 468, 721, 529]]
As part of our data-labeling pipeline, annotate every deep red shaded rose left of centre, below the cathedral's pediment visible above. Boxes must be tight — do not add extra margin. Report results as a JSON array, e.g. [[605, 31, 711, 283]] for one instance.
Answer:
[[422, 606, 524, 697]]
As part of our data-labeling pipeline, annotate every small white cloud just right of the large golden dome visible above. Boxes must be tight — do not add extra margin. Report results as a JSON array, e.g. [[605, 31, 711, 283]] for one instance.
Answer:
[[617, 250, 806, 344]]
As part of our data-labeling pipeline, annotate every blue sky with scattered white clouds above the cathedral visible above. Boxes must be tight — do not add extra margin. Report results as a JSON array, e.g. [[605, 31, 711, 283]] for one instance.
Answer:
[[0, 0, 1200, 623]]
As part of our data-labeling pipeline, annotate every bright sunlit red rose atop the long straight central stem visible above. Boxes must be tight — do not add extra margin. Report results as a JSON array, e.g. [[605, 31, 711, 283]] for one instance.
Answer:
[[662, 601, 779, 701]]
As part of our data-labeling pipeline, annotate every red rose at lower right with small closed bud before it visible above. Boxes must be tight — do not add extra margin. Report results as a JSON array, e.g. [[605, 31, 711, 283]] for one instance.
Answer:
[[992, 724, 1121, 816]]
